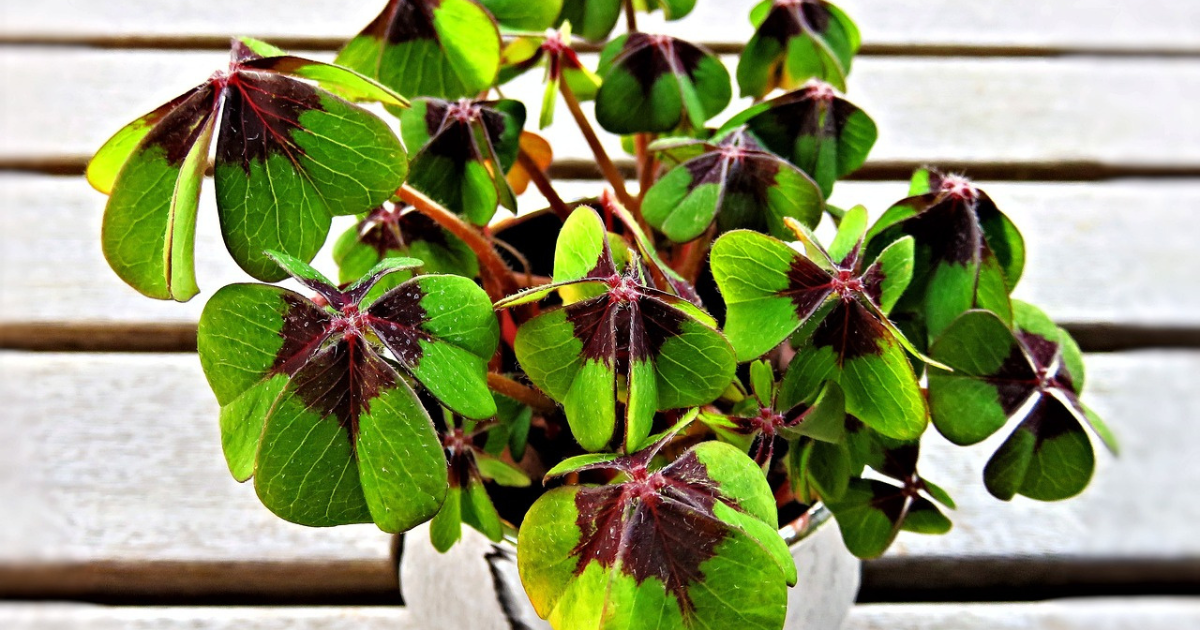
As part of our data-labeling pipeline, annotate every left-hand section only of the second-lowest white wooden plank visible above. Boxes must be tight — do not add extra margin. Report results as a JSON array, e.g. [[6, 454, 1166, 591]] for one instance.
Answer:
[[0, 353, 392, 592]]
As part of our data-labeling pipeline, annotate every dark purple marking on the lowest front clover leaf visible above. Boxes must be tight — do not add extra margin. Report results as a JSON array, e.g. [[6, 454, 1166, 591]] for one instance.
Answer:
[[572, 449, 730, 616]]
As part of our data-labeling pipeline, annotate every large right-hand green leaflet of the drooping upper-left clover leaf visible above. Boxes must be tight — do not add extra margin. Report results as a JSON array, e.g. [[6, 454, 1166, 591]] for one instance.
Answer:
[[215, 82, 407, 281]]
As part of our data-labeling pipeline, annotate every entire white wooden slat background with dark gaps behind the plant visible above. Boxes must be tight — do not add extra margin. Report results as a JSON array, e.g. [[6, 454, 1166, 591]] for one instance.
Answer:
[[0, 0, 1200, 630]]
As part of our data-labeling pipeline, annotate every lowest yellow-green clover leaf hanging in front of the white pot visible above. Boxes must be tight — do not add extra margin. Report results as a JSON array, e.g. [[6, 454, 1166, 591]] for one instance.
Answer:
[[517, 442, 796, 630]]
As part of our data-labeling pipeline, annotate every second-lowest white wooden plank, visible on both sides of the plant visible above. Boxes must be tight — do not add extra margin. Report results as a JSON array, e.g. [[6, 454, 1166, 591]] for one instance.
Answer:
[[0, 352, 1200, 592]]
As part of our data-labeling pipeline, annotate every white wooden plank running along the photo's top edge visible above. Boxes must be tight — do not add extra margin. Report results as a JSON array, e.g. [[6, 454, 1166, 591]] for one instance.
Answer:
[[0, 0, 1200, 52]]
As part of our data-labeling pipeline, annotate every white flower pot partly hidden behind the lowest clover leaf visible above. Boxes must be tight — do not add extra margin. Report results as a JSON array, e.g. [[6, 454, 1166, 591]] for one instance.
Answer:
[[400, 508, 859, 630]]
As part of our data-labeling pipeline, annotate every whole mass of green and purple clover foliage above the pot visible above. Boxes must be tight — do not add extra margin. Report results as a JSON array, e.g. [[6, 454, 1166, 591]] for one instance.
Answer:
[[88, 0, 1115, 629]]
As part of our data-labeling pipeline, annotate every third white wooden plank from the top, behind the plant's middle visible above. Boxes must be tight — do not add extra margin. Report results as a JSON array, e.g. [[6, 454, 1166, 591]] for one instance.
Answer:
[[0, 174, 1200, 329]]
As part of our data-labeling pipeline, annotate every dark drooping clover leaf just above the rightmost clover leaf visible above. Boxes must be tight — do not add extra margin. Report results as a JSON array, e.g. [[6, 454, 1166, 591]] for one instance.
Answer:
[[868, 169, 1025, 340]]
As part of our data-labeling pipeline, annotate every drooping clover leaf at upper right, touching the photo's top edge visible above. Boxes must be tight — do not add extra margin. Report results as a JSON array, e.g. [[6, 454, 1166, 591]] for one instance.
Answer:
[[738, 0, 860, 98]]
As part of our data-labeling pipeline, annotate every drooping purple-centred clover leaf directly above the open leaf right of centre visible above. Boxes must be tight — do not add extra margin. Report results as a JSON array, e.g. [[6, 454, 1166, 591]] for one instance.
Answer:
[[642, 130, 824, 242]]
